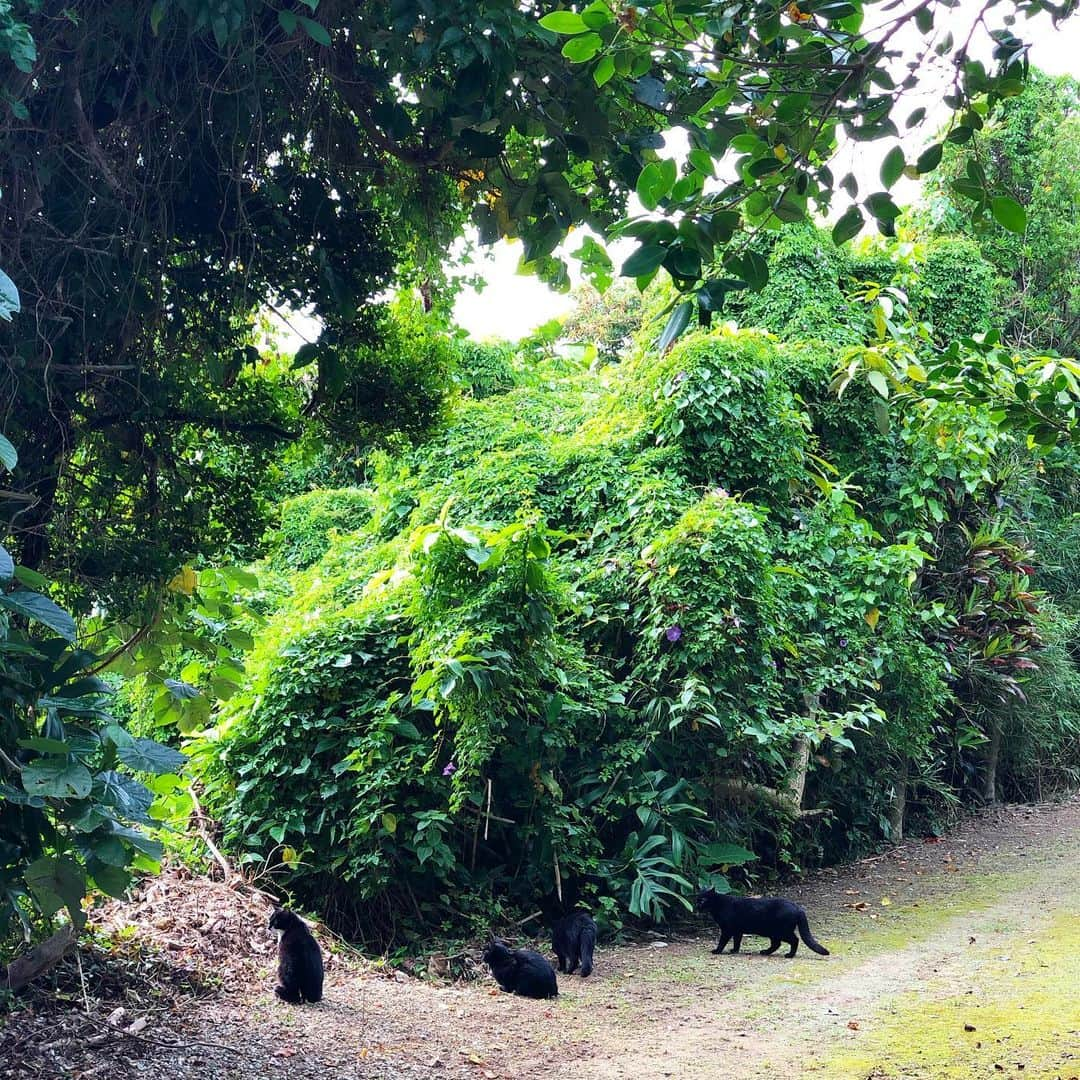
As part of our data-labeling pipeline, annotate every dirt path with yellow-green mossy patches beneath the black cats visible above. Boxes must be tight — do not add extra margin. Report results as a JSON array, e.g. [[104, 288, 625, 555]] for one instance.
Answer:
[[0, 800, 1080, 1080]]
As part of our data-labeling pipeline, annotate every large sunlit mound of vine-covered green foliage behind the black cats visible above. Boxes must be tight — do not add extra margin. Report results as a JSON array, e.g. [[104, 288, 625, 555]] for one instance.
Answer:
[[190, 295, 1075, 943]]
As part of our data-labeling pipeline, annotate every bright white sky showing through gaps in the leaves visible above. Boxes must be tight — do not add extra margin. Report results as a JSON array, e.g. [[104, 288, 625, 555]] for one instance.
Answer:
[[455, 0, 1080, 339]]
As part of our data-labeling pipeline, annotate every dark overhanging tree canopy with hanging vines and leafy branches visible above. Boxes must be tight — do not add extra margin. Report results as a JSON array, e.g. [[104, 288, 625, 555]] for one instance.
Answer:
[[0, 0, 1072, 600]]
